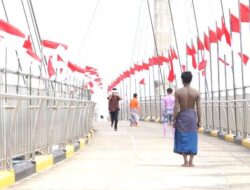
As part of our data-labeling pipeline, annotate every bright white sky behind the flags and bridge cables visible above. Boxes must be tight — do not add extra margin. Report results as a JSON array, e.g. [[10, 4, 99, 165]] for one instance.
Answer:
[[0, 0, 250, 119]]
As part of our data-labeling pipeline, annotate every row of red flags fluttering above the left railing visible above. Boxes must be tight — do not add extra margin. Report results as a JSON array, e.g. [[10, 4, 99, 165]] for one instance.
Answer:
[[0, 19, 103, 94]]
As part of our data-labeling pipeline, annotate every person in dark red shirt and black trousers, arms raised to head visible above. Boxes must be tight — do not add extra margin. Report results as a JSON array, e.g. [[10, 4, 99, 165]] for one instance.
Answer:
[[107, 88, 122, 131]]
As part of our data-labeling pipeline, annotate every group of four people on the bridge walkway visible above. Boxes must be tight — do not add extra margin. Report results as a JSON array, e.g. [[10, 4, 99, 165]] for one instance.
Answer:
[[107, 71, 201, 167]]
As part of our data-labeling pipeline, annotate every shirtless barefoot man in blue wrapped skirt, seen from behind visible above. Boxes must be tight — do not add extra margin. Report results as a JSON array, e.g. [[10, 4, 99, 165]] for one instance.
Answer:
[[173, 71, 201, 167]]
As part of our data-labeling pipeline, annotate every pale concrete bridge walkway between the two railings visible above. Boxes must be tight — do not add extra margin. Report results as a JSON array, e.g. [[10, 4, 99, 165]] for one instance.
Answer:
[[8, 121, 250, 190]]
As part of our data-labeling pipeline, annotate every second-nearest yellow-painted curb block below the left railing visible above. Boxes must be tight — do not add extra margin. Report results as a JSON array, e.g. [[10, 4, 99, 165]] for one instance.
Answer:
[[35, 154, 53, 172]]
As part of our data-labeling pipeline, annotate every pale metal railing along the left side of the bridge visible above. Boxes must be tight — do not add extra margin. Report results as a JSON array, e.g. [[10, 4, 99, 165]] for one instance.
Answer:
[[0, 93, 95, 169]]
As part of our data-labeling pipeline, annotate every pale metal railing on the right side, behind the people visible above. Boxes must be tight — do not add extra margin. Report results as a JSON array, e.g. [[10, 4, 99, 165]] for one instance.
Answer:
[[120, 96, 250, 139]]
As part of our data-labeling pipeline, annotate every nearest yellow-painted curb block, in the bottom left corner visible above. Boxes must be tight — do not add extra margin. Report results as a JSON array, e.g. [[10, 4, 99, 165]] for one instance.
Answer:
[[0, 170, 15, 189]]
